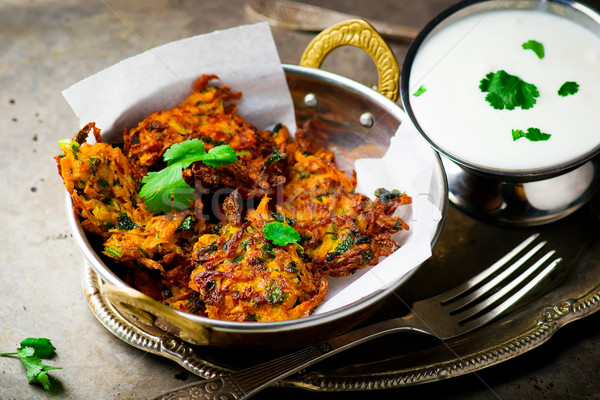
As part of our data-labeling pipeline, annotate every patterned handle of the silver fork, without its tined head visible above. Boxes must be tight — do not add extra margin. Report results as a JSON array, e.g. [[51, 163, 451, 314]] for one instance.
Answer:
[[155, 312, 431, 400]]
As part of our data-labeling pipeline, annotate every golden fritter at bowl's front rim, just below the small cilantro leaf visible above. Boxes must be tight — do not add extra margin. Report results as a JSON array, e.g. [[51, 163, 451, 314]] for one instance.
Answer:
[[190, 198, 327, 322]]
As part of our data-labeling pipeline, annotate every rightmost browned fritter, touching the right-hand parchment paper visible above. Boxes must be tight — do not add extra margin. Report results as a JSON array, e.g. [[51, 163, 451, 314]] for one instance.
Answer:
[[278, 131, 411, 276]]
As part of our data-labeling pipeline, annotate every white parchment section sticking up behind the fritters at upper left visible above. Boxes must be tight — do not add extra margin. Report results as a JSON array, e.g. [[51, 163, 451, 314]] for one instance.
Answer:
[[63, 22, 296, 138]]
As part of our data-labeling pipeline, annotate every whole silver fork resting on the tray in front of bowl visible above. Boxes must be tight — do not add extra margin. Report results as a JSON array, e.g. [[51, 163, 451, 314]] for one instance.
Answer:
[[155, 233, 562, 400]]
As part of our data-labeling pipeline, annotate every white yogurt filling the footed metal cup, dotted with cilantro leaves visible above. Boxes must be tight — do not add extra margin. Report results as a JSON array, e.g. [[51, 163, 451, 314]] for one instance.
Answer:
[[409, 10, 600, 170]]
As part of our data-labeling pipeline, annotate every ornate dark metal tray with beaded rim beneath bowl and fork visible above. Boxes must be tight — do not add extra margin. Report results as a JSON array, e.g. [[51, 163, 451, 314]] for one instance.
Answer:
[[83, 196, 600, 391]]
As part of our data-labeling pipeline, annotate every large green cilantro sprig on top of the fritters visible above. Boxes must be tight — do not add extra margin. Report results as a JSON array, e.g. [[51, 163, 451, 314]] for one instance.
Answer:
[[139, 139, 248, 214]]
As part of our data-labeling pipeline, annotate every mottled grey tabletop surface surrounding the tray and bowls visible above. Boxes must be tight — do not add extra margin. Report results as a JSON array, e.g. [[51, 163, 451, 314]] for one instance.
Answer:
[[0, 0, 600, 400]]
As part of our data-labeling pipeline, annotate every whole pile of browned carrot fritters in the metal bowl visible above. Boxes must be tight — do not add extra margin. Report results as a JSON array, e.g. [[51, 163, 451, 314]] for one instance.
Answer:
[[56, 75, 411, 321]]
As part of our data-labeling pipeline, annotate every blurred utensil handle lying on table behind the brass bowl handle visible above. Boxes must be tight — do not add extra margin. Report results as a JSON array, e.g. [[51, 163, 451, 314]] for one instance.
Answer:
[[245, 0, 419, 40]]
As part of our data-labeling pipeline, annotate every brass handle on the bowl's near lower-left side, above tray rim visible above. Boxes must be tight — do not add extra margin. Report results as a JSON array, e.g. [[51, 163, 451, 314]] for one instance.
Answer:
[[101, 284, 210, 345]]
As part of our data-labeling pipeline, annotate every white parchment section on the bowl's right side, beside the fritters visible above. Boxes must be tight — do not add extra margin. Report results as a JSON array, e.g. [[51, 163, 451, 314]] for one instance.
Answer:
[[315, 121, 442, 314]]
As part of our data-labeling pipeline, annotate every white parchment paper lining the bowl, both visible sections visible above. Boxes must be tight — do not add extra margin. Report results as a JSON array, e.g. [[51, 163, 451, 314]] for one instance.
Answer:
[[63, 23, 441, 313]]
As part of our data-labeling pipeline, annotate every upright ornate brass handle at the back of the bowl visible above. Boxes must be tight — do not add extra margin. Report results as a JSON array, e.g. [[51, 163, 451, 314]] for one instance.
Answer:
[[300, 19, 400, 101]]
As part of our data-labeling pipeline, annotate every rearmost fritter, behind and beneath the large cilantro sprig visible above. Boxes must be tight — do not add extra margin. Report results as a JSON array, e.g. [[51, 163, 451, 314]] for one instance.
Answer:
[[124, 75, 289, 197]]
